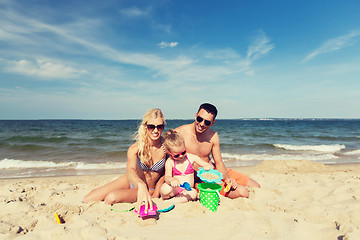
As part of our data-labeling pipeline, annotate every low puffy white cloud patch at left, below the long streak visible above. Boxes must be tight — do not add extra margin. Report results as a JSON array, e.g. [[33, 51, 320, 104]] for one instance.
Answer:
[[7, 59, 86, 79]]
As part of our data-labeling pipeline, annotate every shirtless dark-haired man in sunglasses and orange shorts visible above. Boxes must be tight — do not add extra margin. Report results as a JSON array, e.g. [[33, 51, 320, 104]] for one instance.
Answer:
[[176, 103, 260, 199]]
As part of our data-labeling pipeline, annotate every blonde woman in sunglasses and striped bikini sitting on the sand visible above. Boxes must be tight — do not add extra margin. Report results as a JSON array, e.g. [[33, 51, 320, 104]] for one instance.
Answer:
[[84, 108, 166, 212]]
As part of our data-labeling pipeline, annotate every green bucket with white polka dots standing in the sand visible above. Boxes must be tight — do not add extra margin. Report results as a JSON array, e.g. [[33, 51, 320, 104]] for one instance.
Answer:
[[197, 183, 222, 212]]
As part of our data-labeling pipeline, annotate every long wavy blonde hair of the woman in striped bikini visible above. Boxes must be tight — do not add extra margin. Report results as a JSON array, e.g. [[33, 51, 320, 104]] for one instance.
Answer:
[[134, 108, 165, 166]]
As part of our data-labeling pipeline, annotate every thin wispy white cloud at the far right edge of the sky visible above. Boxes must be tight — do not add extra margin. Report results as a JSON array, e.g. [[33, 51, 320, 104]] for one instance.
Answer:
[[303, 31, 360, 62]]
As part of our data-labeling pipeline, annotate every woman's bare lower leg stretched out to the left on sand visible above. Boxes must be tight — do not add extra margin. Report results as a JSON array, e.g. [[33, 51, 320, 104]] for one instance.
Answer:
[[83, 174, 130, 203]]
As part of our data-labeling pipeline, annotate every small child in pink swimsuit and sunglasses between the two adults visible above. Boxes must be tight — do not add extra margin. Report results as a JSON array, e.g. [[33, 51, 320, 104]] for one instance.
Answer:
[[160, 129, 214, 203]]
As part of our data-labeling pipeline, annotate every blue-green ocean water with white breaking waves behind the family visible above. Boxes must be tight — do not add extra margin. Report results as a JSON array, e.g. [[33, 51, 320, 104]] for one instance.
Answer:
[[0, 119, 360, 178]]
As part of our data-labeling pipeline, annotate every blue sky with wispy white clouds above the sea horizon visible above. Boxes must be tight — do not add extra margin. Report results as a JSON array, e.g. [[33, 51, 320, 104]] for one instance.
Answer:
[[0, 0, 360, 119]]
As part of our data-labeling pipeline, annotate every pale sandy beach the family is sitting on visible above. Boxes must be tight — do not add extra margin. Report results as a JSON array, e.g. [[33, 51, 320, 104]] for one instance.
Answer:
[[0, 160, 360, 240]]
